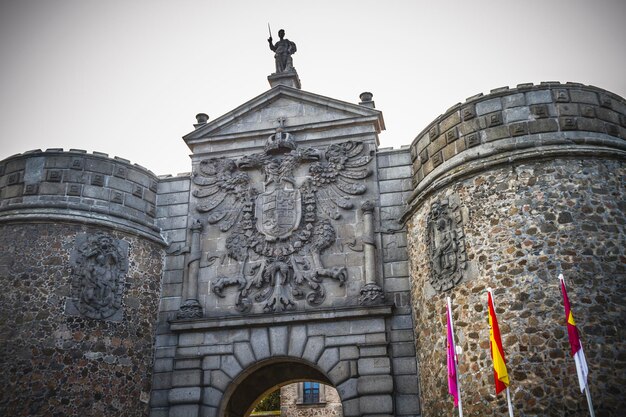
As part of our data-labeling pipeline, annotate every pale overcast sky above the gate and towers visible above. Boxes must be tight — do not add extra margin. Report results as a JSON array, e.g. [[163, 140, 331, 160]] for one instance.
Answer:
[[0, 0, 626, 174]]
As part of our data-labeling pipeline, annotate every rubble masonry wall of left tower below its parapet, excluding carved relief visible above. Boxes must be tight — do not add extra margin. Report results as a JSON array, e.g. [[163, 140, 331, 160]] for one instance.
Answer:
[[0, 223, 162, 417]]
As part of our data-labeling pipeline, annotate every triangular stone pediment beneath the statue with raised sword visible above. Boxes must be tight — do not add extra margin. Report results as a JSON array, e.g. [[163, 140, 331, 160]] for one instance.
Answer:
[[183, 85, 385, 149]]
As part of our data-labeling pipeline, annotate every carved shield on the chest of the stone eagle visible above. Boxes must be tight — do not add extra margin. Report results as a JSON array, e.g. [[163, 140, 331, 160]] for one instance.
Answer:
[[256, 189, 302, 240]]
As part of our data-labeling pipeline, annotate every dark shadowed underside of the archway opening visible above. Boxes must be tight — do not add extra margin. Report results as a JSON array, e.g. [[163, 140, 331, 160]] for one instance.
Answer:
[[219, 358, 333, 417]]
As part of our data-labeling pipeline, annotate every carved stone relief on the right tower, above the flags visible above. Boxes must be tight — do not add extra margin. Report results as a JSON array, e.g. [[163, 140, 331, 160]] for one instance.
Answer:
[[426, 199, 466, 291]]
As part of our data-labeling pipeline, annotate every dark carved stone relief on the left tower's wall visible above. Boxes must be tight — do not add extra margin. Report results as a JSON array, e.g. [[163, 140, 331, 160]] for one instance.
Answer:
[[65, 232, 128, 321]]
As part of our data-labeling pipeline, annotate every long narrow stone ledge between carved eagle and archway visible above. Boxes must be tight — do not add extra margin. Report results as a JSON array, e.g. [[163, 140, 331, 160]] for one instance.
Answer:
[[169, 305, 393, 332]]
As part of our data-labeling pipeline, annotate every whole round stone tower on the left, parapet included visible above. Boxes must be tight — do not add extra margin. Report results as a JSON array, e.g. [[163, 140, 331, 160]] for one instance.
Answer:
[[0, 149, 164, 416]]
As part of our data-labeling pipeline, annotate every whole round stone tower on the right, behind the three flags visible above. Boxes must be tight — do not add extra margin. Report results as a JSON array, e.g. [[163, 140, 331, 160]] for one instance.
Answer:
[[405, 83, 626, 417]]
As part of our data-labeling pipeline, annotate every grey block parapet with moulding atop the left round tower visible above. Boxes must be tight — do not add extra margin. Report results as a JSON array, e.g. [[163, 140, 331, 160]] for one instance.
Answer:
[[0, 148, 163, 243]]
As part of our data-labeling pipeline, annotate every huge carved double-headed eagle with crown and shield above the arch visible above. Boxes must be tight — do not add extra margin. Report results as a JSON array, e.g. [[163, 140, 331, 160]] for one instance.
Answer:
[[193, 127, 371, 312]]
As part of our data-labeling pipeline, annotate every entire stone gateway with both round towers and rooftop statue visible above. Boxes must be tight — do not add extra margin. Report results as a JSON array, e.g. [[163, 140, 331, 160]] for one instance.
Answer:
[[0, 31, 626, 417]]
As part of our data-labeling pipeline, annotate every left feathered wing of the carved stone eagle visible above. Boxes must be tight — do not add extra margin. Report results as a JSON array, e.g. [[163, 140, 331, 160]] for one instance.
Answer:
[[192, 158, 252, 232]]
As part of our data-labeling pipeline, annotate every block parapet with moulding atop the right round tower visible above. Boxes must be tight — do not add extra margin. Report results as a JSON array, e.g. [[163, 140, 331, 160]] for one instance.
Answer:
[[405, 82, 626, 218]]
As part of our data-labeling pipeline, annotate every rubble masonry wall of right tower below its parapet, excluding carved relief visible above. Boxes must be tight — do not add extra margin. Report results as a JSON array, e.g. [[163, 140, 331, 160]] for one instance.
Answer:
[[409, 157, 626, 417]]
